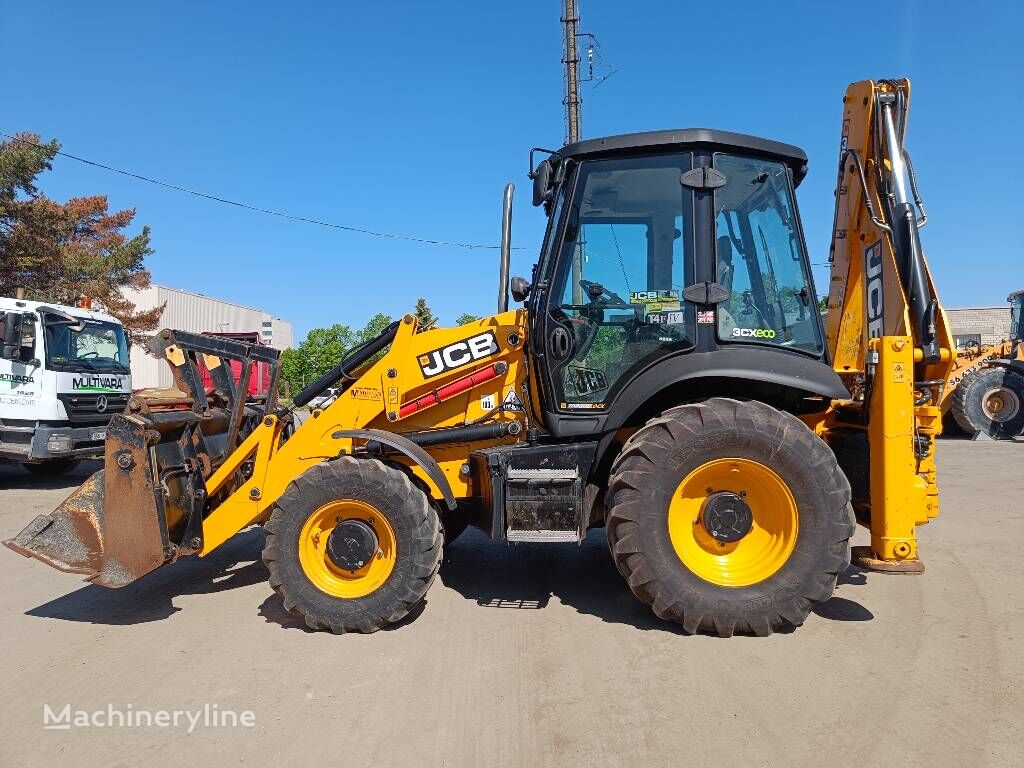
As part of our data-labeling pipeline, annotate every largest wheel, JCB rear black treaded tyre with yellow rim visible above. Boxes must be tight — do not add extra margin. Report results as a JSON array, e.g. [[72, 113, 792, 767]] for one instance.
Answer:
[[607, 398, 854, 637]]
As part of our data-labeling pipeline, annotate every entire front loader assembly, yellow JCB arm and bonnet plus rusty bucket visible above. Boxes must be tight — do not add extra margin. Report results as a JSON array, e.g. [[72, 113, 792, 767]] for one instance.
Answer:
[[5, 310, 529, 587]]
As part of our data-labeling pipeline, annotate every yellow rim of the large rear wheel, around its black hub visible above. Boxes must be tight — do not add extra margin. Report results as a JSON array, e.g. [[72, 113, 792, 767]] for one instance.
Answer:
[[669, 459, 799, 587]]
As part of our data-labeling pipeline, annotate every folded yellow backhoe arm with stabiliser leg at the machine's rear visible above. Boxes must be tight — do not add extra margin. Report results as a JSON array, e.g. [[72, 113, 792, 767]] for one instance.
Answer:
[[826, 80, 953, 571]]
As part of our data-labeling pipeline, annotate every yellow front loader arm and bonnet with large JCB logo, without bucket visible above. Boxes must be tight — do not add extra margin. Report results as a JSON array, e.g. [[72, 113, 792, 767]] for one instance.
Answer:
[[199, 311, 526, 555]]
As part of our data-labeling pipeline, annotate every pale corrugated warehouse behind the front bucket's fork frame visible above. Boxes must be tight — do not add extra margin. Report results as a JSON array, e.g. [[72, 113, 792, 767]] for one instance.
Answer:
[[124, 285, 293, 389]]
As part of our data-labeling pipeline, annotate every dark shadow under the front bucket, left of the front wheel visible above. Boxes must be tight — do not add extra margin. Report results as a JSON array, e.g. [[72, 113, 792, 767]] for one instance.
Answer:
[[26, 527, 267, 626]]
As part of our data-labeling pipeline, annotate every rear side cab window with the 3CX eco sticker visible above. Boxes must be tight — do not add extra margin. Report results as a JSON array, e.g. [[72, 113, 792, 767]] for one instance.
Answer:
[[715, 155, 822, 354]]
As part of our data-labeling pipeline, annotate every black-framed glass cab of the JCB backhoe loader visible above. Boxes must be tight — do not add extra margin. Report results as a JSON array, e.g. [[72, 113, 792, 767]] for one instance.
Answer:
[[527, 129, 847, 436]]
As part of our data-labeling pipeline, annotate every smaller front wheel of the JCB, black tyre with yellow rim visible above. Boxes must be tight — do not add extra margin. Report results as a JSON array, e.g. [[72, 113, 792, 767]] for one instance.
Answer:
[[263, 457, 441, 634]]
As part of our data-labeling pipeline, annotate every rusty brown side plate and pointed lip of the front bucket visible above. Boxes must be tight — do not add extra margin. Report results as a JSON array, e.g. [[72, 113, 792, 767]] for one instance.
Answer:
[[4, 416, 175, 587]]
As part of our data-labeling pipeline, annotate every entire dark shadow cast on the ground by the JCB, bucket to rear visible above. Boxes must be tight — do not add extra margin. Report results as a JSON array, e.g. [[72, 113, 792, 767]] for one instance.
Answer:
[[26, 527, 873, 634]]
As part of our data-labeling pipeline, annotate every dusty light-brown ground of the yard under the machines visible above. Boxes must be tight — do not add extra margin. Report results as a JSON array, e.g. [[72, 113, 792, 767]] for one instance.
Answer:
[[0, 440, 1024, 768]]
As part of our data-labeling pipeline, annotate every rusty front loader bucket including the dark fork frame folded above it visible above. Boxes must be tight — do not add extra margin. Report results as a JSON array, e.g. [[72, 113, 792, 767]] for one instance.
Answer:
[[4, 331, 279, 587]]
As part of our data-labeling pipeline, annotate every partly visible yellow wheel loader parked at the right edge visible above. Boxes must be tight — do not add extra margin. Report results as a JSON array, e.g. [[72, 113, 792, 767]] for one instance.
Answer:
[[939, 291, 1024, 439]]
